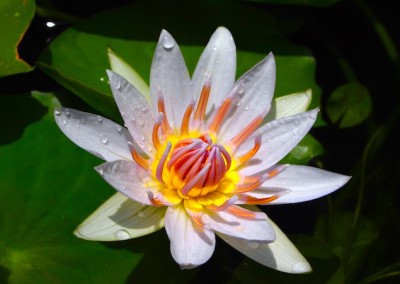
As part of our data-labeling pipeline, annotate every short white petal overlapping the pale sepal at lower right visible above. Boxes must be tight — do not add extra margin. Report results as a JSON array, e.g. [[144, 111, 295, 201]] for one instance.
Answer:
[[203, 211, 275, 242]]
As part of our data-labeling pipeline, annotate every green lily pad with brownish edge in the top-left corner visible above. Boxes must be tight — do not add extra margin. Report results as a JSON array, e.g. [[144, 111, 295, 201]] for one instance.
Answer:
[[0, 0, 35, 77]]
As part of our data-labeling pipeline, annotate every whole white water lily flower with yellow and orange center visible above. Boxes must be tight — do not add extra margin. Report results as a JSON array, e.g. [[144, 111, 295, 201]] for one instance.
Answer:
[[55, 27, 349, 273]]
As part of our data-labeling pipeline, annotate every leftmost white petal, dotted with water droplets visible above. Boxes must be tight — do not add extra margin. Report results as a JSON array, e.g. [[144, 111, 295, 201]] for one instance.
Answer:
[[54, 108, 133, 161]]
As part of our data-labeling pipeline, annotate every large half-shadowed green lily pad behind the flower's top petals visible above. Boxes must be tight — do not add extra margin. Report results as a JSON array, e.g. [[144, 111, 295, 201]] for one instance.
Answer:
[[37, 1, 322, 124]]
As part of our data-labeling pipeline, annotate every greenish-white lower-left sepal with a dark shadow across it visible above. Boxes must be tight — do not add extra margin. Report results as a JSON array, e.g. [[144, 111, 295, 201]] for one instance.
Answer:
[[74, 193, 165, 241]]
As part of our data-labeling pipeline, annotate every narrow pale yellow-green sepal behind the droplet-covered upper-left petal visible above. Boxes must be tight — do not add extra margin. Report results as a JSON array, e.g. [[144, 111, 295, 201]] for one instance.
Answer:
[[107, 48, 150, 101]]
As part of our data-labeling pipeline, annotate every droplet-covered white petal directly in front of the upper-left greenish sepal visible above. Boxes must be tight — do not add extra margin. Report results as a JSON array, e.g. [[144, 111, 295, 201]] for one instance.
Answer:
[[107, 70, 154, 156]]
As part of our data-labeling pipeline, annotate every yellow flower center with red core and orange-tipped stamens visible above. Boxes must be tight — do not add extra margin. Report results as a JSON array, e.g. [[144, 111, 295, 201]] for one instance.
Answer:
[[132, 83, 279, 221]]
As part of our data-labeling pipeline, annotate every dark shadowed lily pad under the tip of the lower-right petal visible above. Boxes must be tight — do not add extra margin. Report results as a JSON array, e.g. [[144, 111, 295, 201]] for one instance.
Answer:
[[228, 235, 344, 284]]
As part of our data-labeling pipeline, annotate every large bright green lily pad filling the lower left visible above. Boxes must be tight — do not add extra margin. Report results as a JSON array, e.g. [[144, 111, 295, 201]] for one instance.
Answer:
[[0, 92, 142, 284]]
